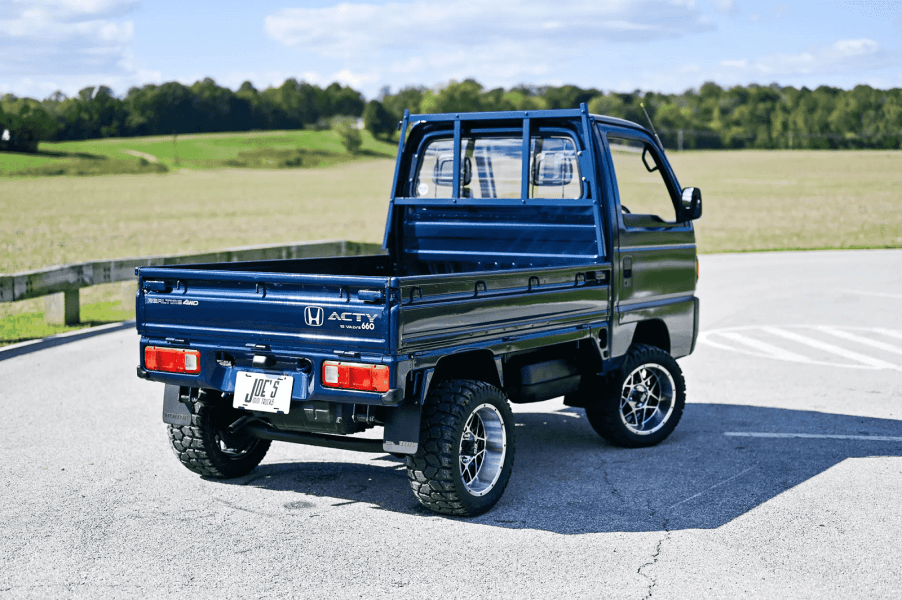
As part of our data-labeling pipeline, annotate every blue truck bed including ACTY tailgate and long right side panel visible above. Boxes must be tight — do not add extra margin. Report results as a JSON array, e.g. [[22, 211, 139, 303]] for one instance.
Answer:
[[137, 256, 610, 354]]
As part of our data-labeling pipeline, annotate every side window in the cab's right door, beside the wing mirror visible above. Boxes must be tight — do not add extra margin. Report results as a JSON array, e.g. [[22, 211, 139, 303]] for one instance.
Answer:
[[608, 134, 676, 226]]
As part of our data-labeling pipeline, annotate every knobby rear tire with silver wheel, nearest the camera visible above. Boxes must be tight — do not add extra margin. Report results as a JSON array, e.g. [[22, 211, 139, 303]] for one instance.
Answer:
[[407, 380, 514, 517]]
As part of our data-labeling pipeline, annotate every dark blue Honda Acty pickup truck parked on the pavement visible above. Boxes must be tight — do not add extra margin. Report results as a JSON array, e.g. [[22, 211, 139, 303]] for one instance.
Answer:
[[137, 105, 702, 516]]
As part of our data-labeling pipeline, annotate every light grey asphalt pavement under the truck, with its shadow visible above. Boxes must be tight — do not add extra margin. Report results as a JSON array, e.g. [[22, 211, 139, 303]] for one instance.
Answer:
[[0, 250, 902, 599]]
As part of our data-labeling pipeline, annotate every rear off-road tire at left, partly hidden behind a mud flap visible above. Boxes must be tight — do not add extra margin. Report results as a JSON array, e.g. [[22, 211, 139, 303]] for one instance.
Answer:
[[169, 390, 272, 479]]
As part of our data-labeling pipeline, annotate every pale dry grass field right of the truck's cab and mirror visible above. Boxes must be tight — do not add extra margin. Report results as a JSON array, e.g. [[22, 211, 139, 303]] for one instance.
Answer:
[[670, 151, 902, 252]]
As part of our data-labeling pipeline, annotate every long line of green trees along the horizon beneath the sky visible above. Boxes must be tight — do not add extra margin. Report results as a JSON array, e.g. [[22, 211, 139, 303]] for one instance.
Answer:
[[0, 78, 902, 151]]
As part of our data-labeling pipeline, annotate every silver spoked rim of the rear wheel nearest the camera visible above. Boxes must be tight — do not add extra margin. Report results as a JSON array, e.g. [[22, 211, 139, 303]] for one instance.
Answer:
[[458, 404, 507, 496]]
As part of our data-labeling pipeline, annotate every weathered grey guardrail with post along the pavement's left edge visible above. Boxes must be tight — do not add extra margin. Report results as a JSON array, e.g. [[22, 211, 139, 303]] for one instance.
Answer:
[[0, 240, 382, 325]]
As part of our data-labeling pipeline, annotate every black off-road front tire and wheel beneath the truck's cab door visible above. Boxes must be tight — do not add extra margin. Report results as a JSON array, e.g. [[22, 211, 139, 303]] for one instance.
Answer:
[[586, 344, 686, 448]]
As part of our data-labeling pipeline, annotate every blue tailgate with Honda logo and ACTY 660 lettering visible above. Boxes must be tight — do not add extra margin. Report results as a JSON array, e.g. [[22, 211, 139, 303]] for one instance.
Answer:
[[137, 267, 390, 351]]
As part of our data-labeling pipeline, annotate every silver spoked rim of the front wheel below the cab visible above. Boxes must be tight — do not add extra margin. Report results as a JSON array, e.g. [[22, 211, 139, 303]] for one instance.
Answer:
[[620, 363, 676, 435]]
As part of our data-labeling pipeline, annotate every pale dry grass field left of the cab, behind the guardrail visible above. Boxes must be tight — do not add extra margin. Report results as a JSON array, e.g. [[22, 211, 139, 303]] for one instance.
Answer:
[[0, 159, 394, 273]]
